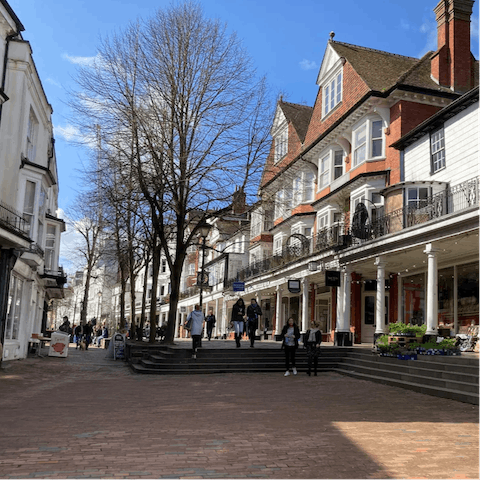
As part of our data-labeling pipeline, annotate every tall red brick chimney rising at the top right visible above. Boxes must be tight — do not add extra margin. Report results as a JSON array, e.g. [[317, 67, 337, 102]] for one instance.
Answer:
[[431, 0, 475, 92]]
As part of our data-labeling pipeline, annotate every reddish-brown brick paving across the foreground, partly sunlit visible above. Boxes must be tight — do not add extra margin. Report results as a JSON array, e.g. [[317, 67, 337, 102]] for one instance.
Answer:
[[0, 349, 480, 480]]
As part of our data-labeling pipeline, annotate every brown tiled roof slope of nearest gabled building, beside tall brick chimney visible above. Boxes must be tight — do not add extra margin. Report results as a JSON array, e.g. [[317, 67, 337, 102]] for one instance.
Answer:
[[329, 40, 451, 93]]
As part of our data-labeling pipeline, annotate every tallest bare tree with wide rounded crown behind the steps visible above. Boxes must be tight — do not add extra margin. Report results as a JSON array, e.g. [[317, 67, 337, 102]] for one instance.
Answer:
[[67, 3, 273, 342]]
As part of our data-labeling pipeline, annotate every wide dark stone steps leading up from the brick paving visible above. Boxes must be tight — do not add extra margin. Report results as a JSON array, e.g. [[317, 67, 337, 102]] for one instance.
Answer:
[[130, 346, 480, 405]]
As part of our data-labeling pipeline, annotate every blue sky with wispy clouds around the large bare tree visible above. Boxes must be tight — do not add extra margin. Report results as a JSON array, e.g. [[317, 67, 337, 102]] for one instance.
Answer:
[[7, 0, 480, 270]]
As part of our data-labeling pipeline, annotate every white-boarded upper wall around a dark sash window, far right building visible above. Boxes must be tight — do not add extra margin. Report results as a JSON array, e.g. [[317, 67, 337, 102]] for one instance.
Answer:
[[405, 102, 480, 186]]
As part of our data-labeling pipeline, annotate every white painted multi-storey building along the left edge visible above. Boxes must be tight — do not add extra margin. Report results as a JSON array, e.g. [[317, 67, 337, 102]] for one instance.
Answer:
[[0, 0, 66, 360]]
